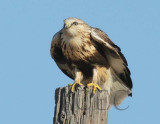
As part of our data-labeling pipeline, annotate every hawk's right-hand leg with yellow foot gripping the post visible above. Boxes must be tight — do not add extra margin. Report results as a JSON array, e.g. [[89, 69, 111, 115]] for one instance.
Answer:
[[87, 67, 102, 93]]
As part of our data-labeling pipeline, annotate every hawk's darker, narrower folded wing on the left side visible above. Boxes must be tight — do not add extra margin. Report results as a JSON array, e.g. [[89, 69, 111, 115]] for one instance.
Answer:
[[50, 32, 73, 79]]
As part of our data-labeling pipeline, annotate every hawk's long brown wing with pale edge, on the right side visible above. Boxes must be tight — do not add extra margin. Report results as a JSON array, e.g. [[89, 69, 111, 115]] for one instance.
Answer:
[[91, 28, 132, 89]]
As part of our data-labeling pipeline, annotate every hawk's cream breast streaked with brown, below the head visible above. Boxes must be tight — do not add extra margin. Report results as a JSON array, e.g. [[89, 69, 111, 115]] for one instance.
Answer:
[[61, 37, 97, 61]]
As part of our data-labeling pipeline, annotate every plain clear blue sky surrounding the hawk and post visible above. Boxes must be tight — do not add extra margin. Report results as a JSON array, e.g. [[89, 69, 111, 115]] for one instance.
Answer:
[[0, 0, 160, 124]]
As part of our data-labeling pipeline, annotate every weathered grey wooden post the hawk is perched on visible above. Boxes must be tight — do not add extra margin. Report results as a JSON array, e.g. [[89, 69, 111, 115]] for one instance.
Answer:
[[53, 86, 109, 124]]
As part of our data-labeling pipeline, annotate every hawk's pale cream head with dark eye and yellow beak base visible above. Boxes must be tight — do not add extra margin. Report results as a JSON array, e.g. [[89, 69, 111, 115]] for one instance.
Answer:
[[63, 18, 90, 36]]
